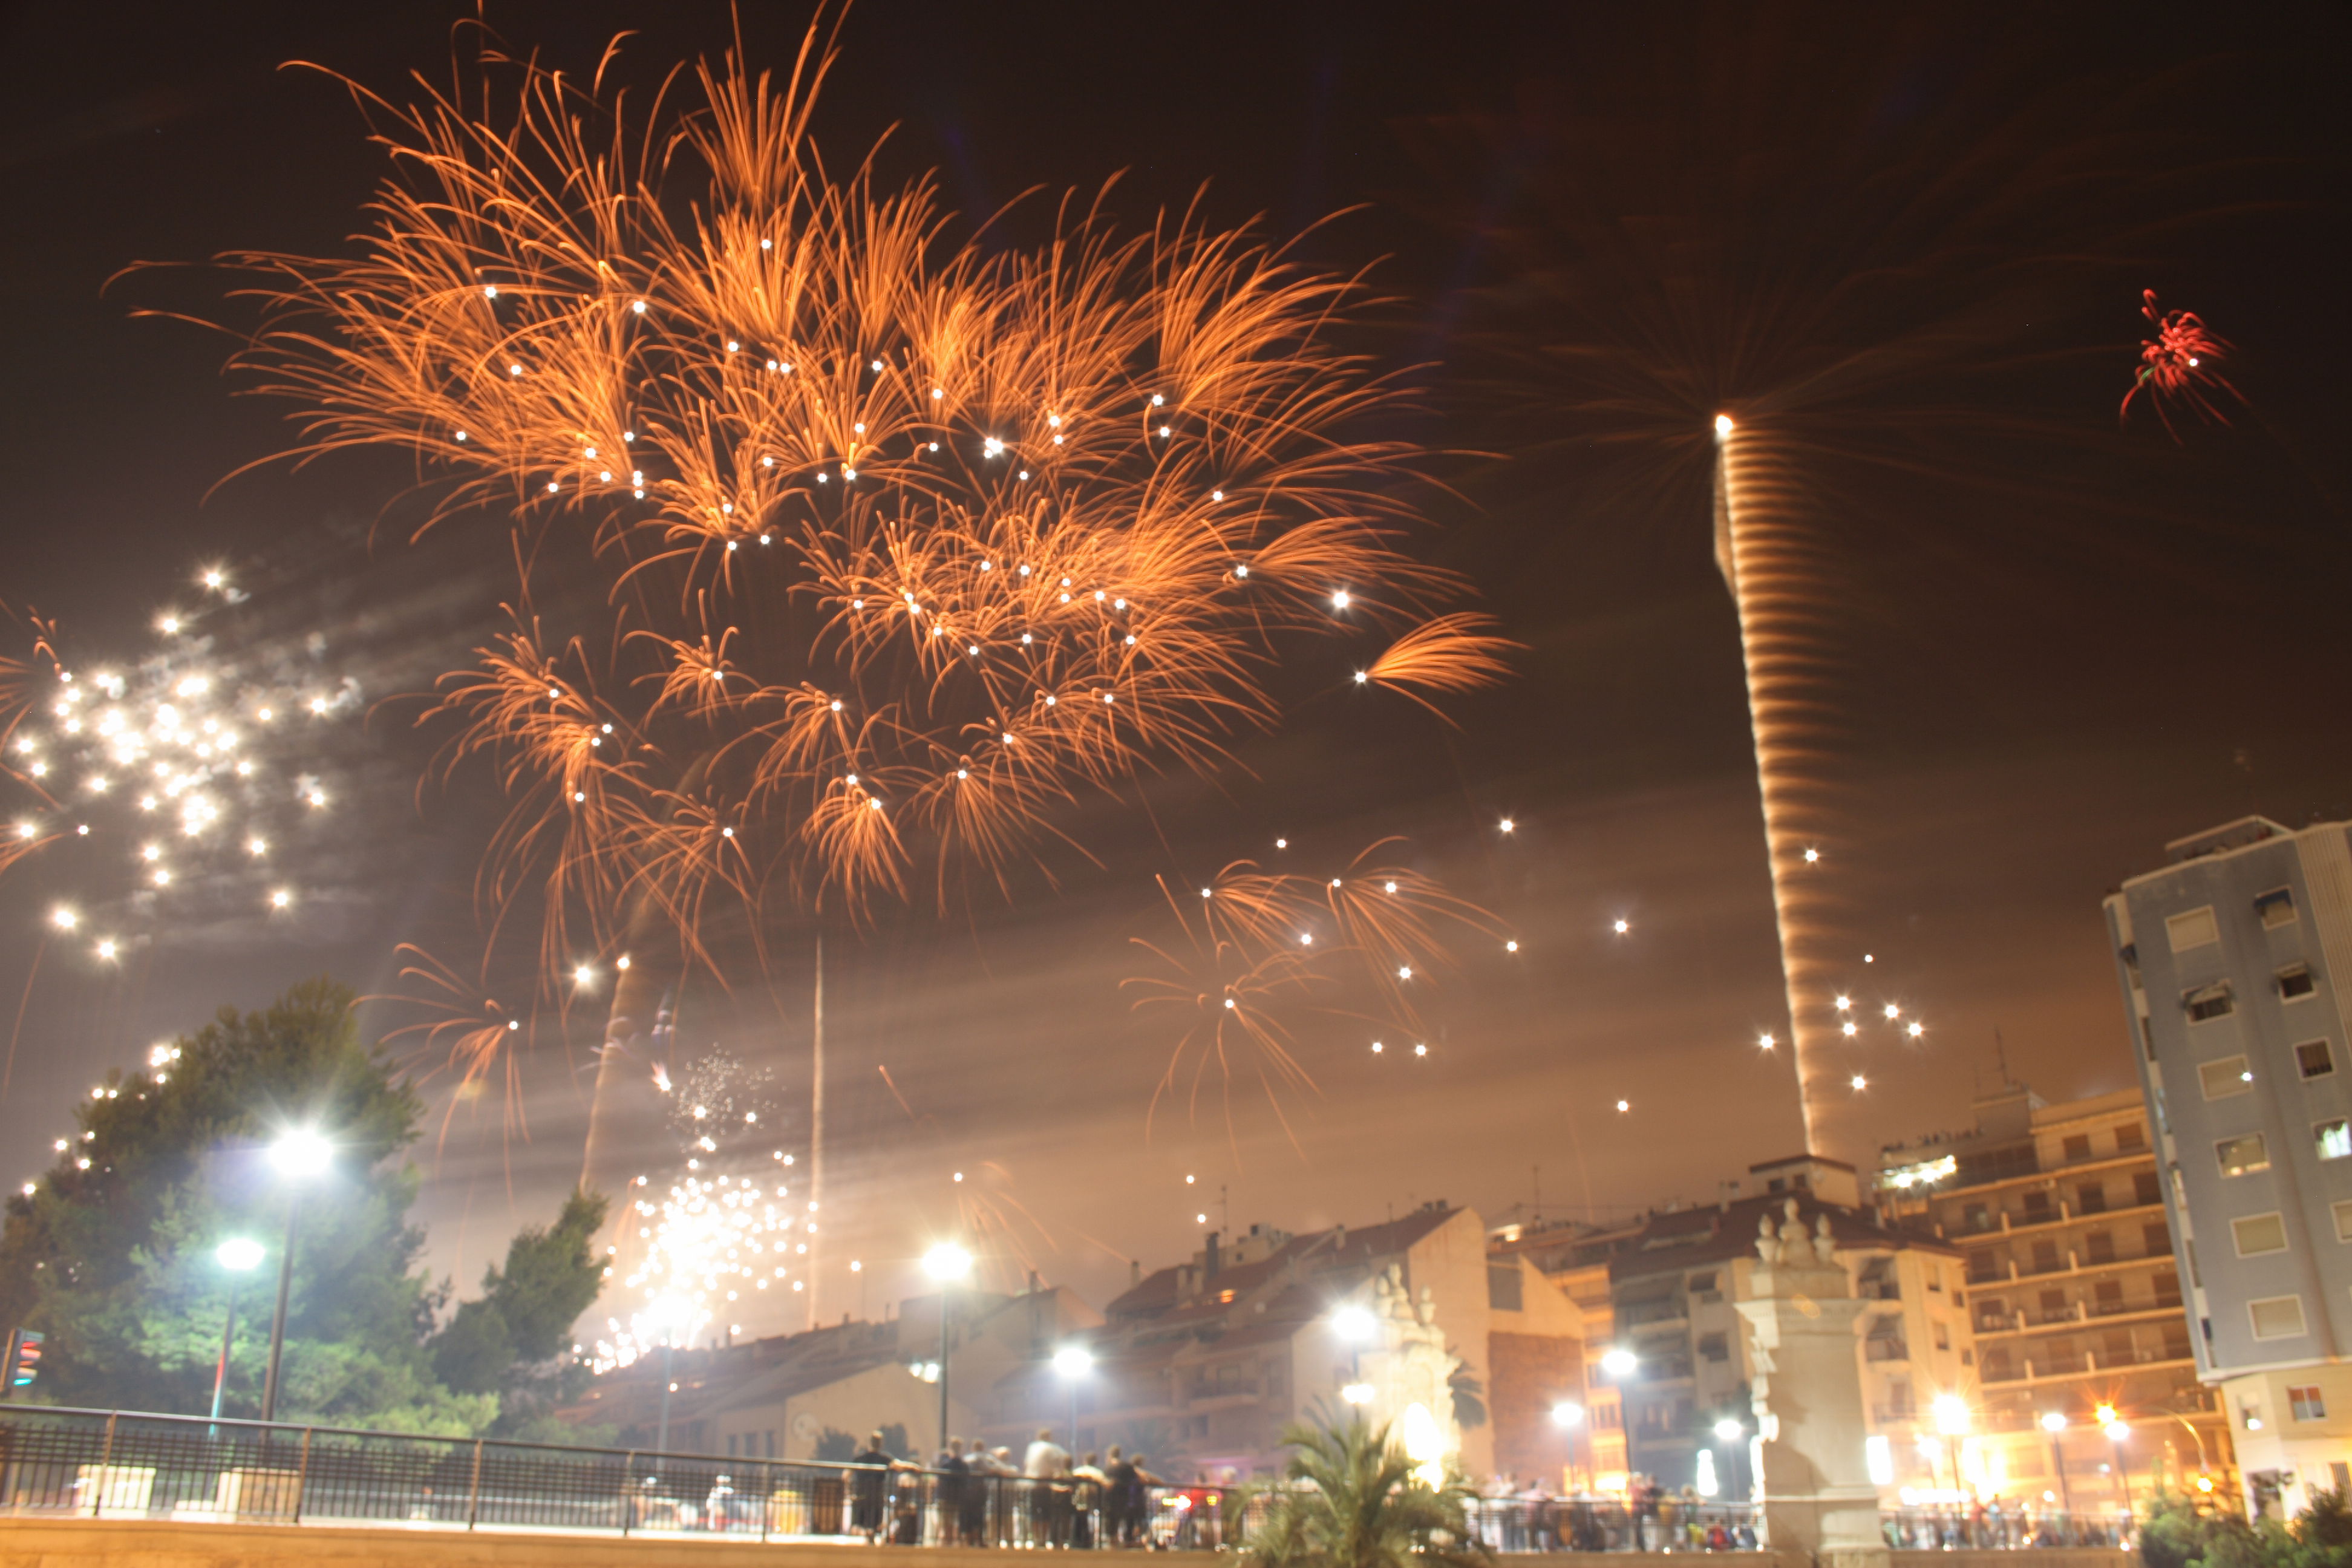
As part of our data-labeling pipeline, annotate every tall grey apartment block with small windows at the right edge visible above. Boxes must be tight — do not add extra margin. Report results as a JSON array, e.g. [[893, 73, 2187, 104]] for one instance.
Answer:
[[2108, 815, 2352, 1512]]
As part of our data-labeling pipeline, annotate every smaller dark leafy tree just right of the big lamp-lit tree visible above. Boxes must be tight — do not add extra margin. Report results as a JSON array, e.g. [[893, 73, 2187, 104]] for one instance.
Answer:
[[433, 1192, 604, 1441]]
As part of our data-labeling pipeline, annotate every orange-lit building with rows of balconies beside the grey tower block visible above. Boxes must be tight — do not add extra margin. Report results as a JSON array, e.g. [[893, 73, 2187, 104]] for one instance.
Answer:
[[1877, 1082, 2235, 1512]]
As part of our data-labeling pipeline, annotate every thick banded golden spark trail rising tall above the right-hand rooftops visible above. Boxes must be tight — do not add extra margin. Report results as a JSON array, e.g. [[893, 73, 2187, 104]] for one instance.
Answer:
[[1714, 421, 1854, 1152]]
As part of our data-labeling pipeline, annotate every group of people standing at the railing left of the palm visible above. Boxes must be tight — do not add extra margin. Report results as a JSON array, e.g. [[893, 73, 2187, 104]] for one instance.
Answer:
[[849, 1427, 1185, 1552]]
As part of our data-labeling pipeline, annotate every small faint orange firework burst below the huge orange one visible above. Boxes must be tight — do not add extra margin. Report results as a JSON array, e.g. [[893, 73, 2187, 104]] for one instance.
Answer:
[[1126, 839, 1498, 1149]]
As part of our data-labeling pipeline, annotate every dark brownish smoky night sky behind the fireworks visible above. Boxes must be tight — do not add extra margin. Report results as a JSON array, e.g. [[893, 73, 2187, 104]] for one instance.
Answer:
[[0, 2, 2352, 1331]]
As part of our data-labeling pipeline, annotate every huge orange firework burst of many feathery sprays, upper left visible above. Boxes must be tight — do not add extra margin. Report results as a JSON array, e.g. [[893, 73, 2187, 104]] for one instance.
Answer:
[[178, 31, 1498, 1222]]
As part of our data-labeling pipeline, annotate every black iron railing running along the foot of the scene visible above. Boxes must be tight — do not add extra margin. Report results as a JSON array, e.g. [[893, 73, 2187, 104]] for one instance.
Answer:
[[0, 1406, 2117, 1552]]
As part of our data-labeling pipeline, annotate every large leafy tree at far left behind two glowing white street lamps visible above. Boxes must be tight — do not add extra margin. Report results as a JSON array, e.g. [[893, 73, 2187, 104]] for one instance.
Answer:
[[0, 980, 593, 1434]]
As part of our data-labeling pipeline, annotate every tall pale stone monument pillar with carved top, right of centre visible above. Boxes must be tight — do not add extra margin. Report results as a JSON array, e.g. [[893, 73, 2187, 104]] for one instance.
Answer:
[[1736, 1199, 1889, 1568]]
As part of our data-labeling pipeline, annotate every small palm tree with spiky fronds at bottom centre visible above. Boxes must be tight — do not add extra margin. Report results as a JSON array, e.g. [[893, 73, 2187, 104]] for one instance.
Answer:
[[1244, 1415, 1491, 1568]]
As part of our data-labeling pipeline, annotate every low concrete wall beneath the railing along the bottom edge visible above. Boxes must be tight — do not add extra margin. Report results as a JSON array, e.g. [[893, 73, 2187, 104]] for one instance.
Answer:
[[0, 1518, 2131, 1568]]
